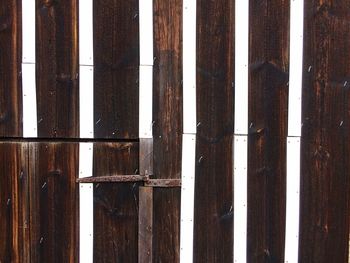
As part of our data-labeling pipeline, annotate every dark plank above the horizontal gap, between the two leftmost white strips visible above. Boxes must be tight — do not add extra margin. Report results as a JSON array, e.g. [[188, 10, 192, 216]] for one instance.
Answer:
[[36, 0, 79, 137]]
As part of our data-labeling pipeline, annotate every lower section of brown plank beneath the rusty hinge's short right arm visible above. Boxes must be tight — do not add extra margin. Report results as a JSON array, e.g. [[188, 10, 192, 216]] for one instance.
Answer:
[[153, 188, 181, 263]]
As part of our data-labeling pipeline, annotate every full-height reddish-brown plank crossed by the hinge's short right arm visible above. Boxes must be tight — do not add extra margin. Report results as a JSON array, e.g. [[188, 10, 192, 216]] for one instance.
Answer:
[[153, 0, 183, 262]]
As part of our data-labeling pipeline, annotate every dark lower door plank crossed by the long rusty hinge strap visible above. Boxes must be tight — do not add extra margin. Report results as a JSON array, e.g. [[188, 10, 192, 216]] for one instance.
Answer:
[[93, 143, 140, 262]]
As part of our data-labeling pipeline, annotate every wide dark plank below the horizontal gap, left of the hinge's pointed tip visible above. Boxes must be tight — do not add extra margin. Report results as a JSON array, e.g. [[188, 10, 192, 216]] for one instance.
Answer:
[[28, 143, 79, 262]]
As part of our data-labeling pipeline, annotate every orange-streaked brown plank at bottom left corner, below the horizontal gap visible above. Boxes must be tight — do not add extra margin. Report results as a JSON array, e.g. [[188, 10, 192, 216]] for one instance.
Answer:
[[0, 143, 30, 262]]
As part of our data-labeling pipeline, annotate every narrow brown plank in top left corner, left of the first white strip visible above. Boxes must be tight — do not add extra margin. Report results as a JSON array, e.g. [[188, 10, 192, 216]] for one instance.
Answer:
[[0, 1, 22, 137]]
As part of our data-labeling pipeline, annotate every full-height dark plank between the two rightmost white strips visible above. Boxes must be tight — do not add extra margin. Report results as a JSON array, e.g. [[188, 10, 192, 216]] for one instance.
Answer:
[[247, 0, 289, 263]]
